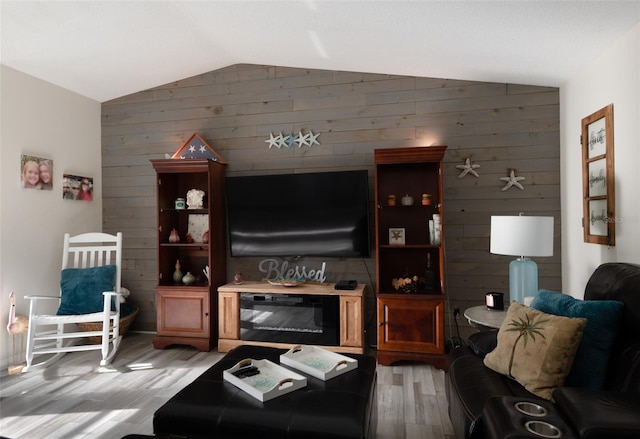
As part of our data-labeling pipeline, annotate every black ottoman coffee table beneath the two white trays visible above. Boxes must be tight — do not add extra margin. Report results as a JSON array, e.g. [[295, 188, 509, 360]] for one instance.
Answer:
[[153, 345, 377, 439]]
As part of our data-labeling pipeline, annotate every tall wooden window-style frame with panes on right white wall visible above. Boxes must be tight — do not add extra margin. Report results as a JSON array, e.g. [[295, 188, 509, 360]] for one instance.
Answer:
[[580, 104, 616, 246]]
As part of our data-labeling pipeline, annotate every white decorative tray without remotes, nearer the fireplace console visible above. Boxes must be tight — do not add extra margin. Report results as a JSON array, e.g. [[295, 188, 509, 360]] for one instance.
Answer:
[[280, 346, 358, 381]]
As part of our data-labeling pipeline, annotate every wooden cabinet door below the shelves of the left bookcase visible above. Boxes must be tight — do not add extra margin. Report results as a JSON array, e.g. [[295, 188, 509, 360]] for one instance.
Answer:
[[156, 287, 211, 338]]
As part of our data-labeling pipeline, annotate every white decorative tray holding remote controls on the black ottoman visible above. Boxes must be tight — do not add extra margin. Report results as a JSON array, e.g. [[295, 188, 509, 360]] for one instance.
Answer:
[[222, 358, 307, 402]]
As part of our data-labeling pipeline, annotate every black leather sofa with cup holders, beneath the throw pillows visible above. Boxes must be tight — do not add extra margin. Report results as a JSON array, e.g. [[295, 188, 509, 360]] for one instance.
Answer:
[[446, 263, 640, 439]]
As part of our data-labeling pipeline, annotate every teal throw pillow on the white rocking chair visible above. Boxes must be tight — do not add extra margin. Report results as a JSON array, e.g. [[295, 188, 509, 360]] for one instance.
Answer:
[[56, 265, 117, 316]]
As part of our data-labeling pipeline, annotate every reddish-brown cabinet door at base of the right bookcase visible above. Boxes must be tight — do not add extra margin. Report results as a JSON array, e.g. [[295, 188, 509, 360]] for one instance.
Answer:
[[378, 295, 444, 354]]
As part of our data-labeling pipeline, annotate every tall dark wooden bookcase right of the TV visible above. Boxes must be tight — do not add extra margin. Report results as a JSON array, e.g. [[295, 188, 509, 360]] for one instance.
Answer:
[[374, 146, 447, 368]]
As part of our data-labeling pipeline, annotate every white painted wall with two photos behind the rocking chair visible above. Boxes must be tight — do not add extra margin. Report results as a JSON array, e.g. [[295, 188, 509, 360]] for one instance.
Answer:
[[0, 66, 102, 368]]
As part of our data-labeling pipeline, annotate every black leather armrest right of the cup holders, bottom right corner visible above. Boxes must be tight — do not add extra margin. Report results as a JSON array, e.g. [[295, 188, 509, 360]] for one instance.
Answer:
[[553, 387, 640, 439]]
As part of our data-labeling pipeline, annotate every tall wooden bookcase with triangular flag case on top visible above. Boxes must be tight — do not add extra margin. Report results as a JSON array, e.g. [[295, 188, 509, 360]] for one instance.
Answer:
[[151, 159, 227, 351]]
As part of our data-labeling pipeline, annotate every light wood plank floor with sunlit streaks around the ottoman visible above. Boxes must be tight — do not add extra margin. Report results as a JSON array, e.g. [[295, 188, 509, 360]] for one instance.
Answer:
[[0, 333, 453, 439]]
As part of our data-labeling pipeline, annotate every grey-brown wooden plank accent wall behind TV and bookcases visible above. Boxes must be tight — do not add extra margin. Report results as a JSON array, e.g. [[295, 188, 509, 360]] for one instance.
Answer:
[[102, 65, 561, 345]]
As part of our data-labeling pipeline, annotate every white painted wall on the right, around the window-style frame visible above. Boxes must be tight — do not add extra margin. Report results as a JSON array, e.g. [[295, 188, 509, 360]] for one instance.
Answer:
[[560, 24, 640, 298]]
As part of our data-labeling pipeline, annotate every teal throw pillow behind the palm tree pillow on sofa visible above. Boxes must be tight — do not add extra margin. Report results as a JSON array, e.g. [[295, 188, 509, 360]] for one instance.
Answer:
[[531, 290, 624, 390]]
